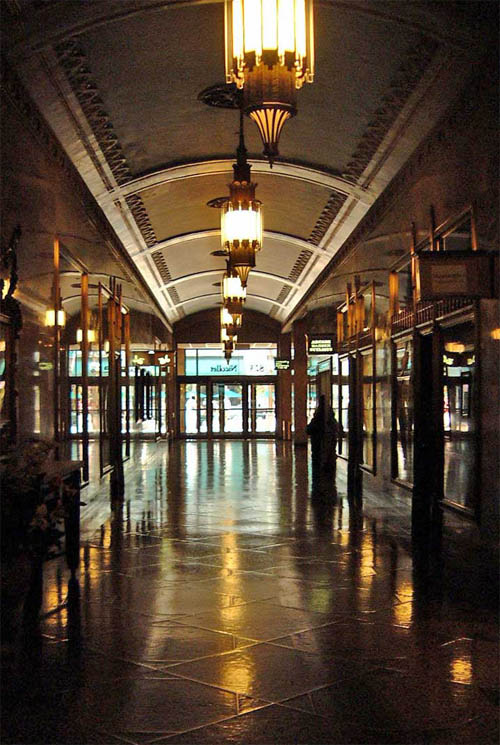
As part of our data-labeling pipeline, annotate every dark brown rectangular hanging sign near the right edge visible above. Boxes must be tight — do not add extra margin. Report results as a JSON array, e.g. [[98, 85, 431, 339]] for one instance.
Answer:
[[417, 251, 493, 300]]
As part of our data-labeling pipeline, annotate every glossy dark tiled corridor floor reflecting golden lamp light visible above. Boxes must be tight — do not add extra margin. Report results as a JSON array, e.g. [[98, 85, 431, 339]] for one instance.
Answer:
[[3, 441, 498, 745]]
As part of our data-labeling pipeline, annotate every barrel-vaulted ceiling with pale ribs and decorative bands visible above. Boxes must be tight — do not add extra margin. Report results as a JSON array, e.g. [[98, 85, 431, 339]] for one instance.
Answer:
[[0, 0, 492, 332]]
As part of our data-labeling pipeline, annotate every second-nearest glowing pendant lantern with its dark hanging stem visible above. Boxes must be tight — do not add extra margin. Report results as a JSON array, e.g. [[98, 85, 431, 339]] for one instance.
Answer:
[[208, 110, 262, 287]]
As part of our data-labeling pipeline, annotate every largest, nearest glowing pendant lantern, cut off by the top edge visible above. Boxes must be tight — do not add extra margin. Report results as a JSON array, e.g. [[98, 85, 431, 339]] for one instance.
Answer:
[[225, 0, 314, 167]]
